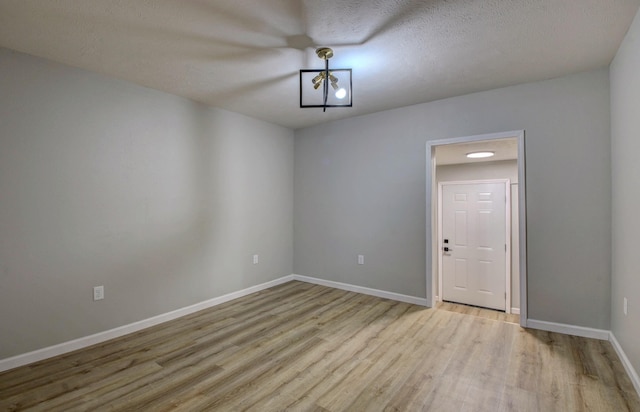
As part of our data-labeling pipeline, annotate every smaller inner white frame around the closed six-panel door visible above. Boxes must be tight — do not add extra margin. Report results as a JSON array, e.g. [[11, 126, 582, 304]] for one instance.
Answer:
[[437, 179, 511, 314]]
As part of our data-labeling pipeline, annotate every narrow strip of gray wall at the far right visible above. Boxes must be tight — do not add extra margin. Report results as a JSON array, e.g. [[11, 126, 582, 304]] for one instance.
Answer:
[[611, 8, 640, 371]]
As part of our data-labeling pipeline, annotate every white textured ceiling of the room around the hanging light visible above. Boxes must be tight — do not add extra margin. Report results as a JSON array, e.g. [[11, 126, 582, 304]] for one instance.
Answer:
[[0, 0, 640, 128]]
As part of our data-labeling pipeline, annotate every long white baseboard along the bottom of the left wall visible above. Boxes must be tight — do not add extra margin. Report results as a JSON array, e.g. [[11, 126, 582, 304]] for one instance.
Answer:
[[0, 275, 294, 372]]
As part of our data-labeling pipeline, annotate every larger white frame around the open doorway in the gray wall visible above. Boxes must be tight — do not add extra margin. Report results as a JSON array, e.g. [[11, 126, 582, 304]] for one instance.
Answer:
[[425, 130, 528, 327]]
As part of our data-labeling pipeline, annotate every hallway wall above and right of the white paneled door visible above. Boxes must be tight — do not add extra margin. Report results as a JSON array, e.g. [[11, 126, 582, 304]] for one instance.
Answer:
[[434, 160, 520, 310]]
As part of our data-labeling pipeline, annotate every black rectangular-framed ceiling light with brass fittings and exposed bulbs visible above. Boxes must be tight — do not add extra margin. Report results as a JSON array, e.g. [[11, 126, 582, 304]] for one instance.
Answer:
[[300, 47, 352, 112]]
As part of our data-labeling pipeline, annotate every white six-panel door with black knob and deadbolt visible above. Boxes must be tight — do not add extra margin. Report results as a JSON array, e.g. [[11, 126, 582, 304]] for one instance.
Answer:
[[440, 181, 508, 310]]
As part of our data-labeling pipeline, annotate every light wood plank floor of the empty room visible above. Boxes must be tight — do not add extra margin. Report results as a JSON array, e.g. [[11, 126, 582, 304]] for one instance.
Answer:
[[0, 282, 640, 412]]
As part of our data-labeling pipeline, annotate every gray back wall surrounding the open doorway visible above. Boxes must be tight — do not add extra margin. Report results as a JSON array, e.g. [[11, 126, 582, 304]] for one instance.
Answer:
[[294, 69, 611, 329]]
